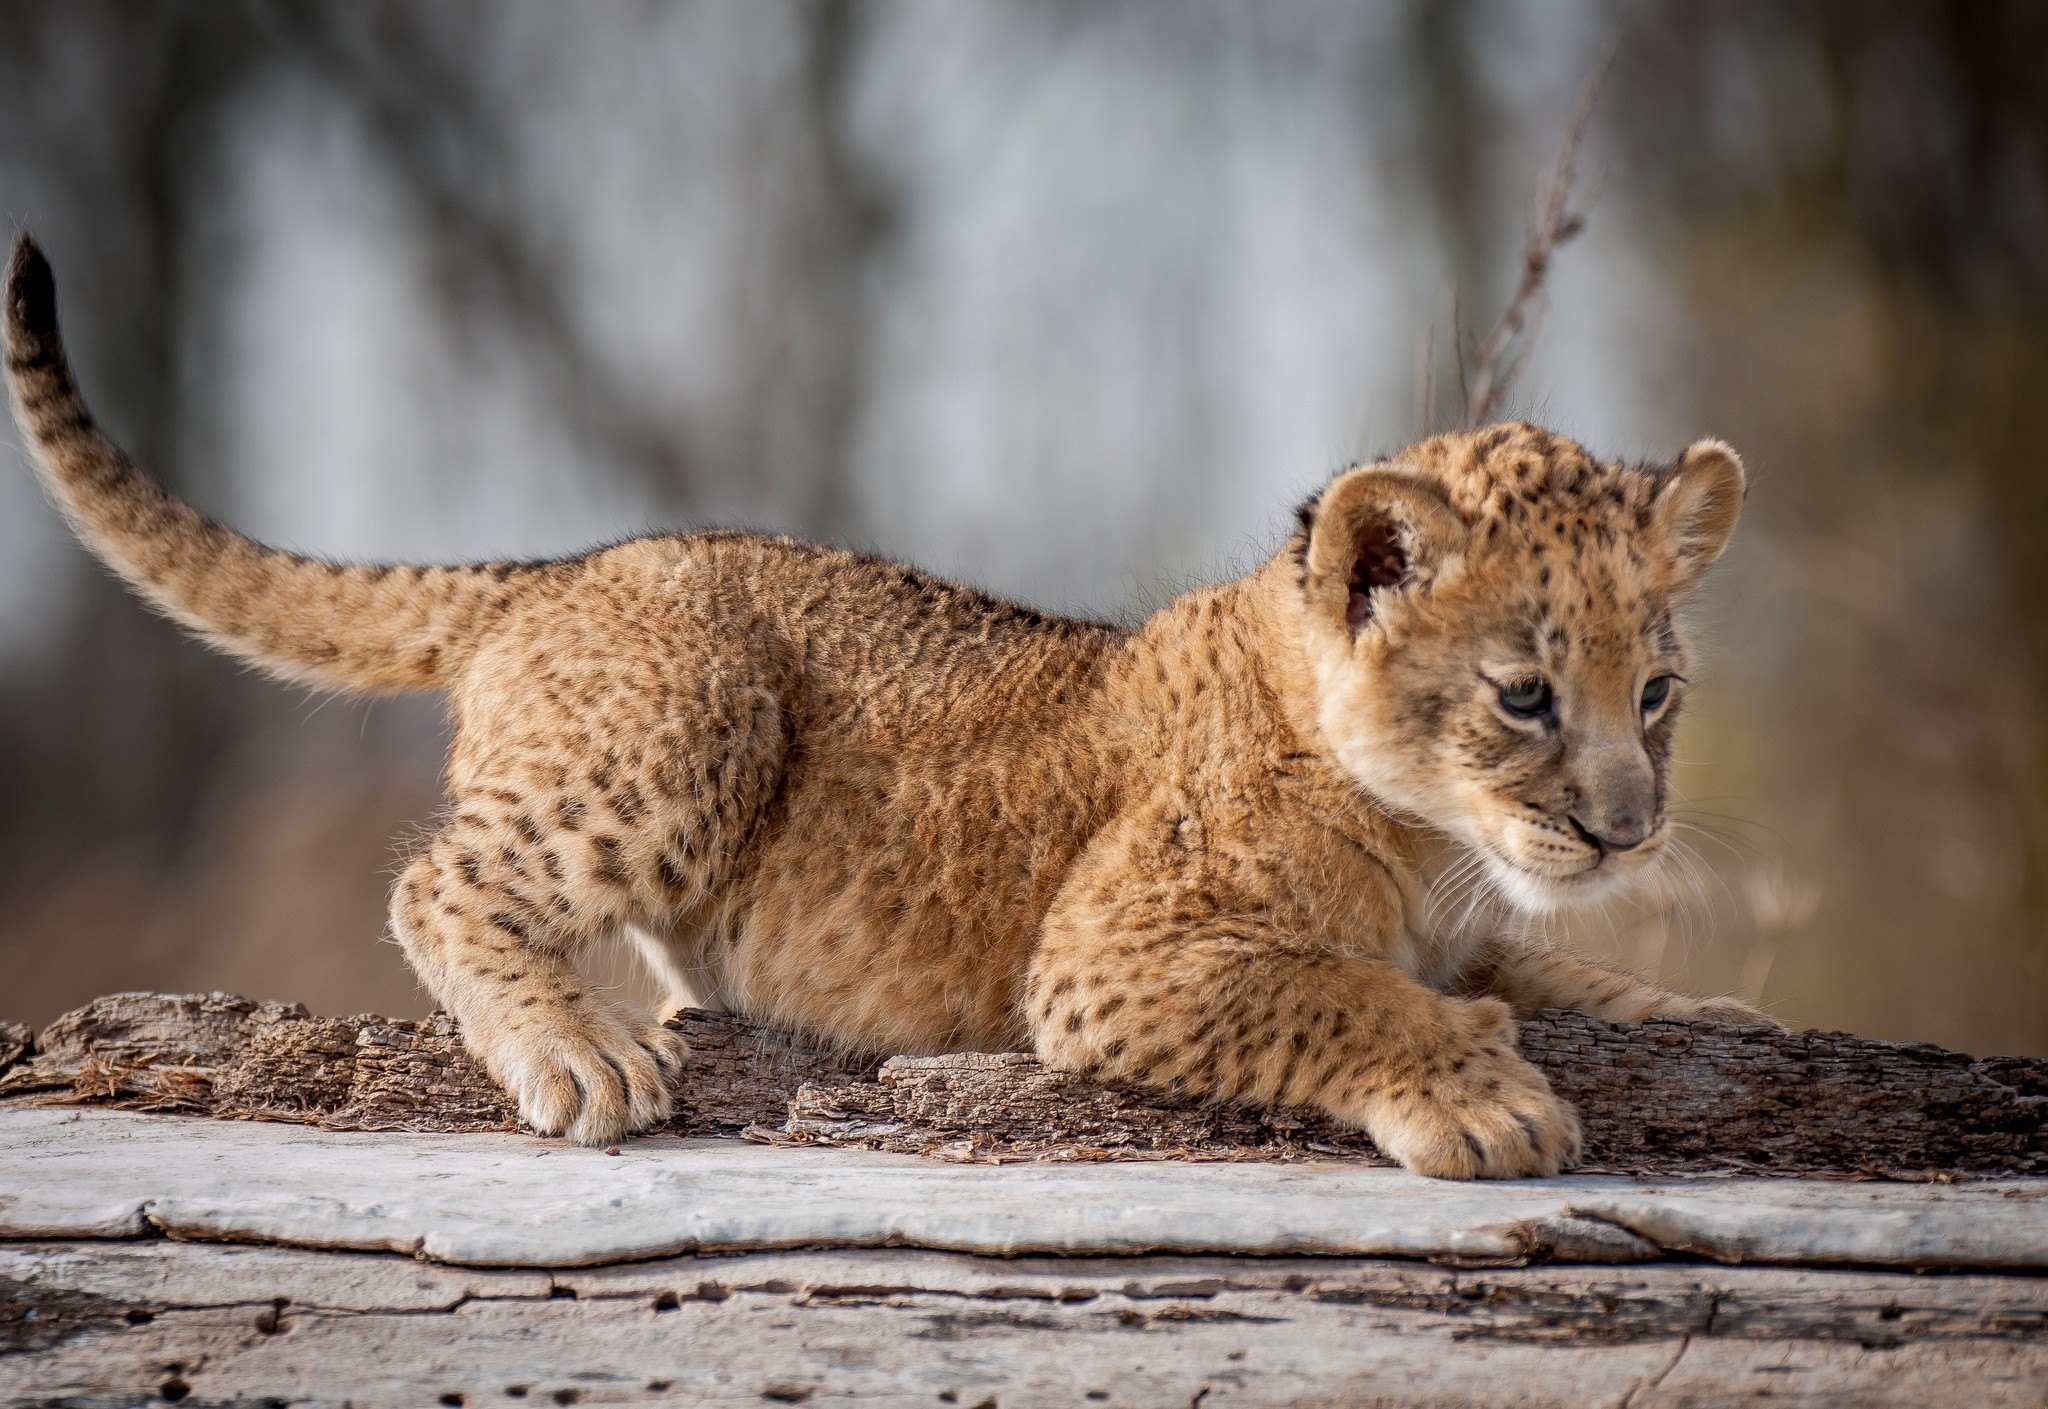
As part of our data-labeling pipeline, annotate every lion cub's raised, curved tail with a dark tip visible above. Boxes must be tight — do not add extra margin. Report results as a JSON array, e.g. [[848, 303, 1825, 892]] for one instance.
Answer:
[[6, 238, 553, 690]]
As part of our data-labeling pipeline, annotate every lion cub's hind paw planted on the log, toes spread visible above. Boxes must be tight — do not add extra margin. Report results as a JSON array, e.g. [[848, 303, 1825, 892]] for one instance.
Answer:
[[463, 993, 690, 1145]]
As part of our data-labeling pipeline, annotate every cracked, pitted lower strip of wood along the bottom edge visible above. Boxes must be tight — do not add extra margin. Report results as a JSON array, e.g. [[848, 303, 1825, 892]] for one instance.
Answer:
[[0, 1241, 2048, 1409]]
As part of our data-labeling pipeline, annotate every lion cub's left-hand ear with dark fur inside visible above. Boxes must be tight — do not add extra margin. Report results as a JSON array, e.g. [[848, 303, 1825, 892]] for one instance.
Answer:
[[1303, 465, 1466, 637]]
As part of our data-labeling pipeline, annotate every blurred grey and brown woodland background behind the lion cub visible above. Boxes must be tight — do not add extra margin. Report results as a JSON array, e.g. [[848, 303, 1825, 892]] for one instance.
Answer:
[[0, 0, 2048, 1053]]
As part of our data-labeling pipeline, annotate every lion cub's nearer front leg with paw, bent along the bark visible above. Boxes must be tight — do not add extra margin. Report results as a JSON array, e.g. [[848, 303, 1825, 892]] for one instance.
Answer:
[[1026, 872, 1579, 1180]]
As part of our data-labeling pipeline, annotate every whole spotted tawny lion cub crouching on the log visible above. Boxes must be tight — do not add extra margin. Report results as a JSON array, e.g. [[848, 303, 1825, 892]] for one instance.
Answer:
[[6, 240, 1755, 1178]]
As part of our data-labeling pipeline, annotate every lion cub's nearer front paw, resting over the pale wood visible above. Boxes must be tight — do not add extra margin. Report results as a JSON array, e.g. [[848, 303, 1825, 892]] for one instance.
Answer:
[[1366, 999, 1581, 1180]]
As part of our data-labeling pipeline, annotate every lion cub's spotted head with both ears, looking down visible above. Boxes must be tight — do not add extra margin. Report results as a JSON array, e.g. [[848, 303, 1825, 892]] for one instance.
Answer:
[[1294, 426, 1745, 909]]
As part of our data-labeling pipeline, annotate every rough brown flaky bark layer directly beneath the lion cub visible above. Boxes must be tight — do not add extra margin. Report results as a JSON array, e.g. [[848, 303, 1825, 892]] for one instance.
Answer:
[[0, 993, 2048, 1178]]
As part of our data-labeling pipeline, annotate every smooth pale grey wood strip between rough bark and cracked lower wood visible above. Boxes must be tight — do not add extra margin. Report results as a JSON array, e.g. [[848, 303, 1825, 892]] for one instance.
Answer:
[[16, 1108, 2048, 1274]]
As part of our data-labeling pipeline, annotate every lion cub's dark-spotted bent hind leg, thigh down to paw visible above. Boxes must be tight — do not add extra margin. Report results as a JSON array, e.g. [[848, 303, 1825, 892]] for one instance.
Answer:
[[391, 671, 782, 1145]]
